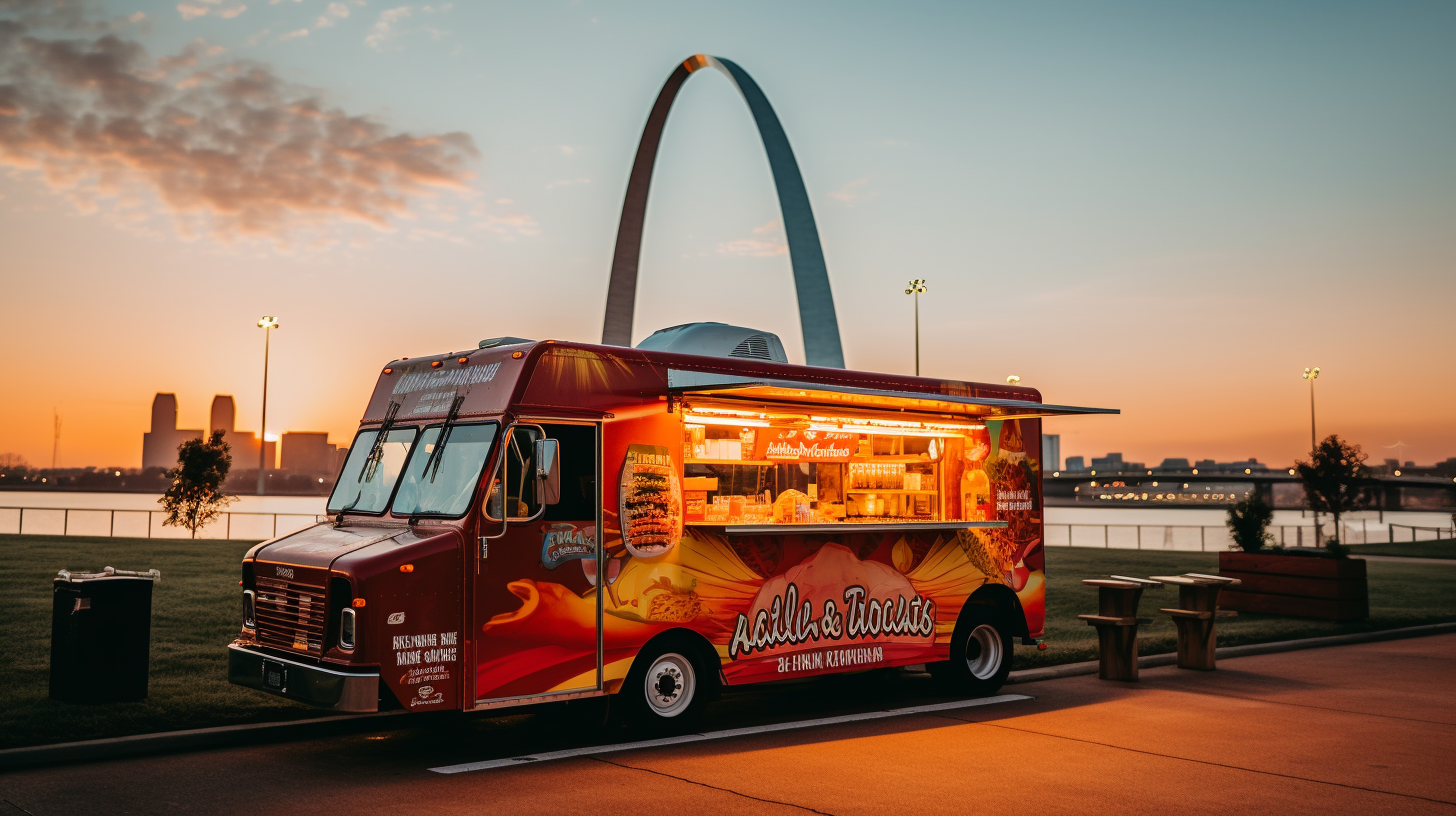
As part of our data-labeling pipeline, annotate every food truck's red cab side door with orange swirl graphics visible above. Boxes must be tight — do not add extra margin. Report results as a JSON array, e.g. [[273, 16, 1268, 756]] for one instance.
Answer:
[[472, 423, 601, 708]]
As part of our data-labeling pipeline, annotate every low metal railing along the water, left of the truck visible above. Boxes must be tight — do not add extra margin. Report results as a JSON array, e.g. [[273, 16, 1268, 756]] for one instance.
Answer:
[[0, 507, 328, 541]]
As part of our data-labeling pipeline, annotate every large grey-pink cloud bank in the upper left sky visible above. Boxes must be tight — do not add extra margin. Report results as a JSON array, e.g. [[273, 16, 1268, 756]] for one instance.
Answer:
[[0, 7, 478, 240]]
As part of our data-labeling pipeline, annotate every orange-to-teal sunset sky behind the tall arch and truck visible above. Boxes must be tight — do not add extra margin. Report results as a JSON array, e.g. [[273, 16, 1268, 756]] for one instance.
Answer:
[[0, 0, 1456, 466]]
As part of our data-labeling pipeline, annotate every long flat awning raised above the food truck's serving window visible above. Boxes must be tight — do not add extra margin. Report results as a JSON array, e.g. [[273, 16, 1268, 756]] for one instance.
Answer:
[[670, 380, 1121, 420]]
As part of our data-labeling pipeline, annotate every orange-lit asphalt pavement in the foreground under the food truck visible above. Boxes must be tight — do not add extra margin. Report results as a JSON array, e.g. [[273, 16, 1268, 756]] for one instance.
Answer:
[[0, 635, 1456, 816]]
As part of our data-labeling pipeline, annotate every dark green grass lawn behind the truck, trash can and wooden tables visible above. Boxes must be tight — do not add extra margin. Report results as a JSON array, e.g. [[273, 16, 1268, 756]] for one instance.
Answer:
[[8, 535, 1456, 748]]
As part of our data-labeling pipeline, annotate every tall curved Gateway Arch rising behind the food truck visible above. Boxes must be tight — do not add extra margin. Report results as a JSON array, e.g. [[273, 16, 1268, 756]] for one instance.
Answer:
[[601, 54, 844, 369]]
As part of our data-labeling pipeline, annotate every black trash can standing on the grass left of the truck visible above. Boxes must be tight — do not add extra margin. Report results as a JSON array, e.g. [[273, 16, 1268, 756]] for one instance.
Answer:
[[51, 567, 162, 702]]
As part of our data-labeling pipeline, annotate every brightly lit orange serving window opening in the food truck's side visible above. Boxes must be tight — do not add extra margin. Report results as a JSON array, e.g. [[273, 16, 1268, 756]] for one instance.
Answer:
[[681, 404, 994, 525]]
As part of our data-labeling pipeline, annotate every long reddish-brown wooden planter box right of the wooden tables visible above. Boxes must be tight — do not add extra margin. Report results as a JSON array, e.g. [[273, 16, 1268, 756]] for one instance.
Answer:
[[1219, 552, 1370, 621]]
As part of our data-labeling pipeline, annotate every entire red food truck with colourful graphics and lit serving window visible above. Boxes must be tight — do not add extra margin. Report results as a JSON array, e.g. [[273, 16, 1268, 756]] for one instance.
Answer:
[[229, 323, 1107, 727]]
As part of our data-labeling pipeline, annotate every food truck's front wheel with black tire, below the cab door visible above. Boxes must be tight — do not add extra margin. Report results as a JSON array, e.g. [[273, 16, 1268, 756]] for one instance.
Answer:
[[613, 638, 716, 734]]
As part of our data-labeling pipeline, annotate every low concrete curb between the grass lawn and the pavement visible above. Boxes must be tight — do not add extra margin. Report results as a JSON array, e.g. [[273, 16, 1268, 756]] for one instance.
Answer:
[[0, 622, 1456, 772]]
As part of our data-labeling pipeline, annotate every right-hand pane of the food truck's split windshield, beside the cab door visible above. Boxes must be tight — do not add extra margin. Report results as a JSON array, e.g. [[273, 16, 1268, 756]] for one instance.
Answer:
[[393, 423, 496, 516]]
